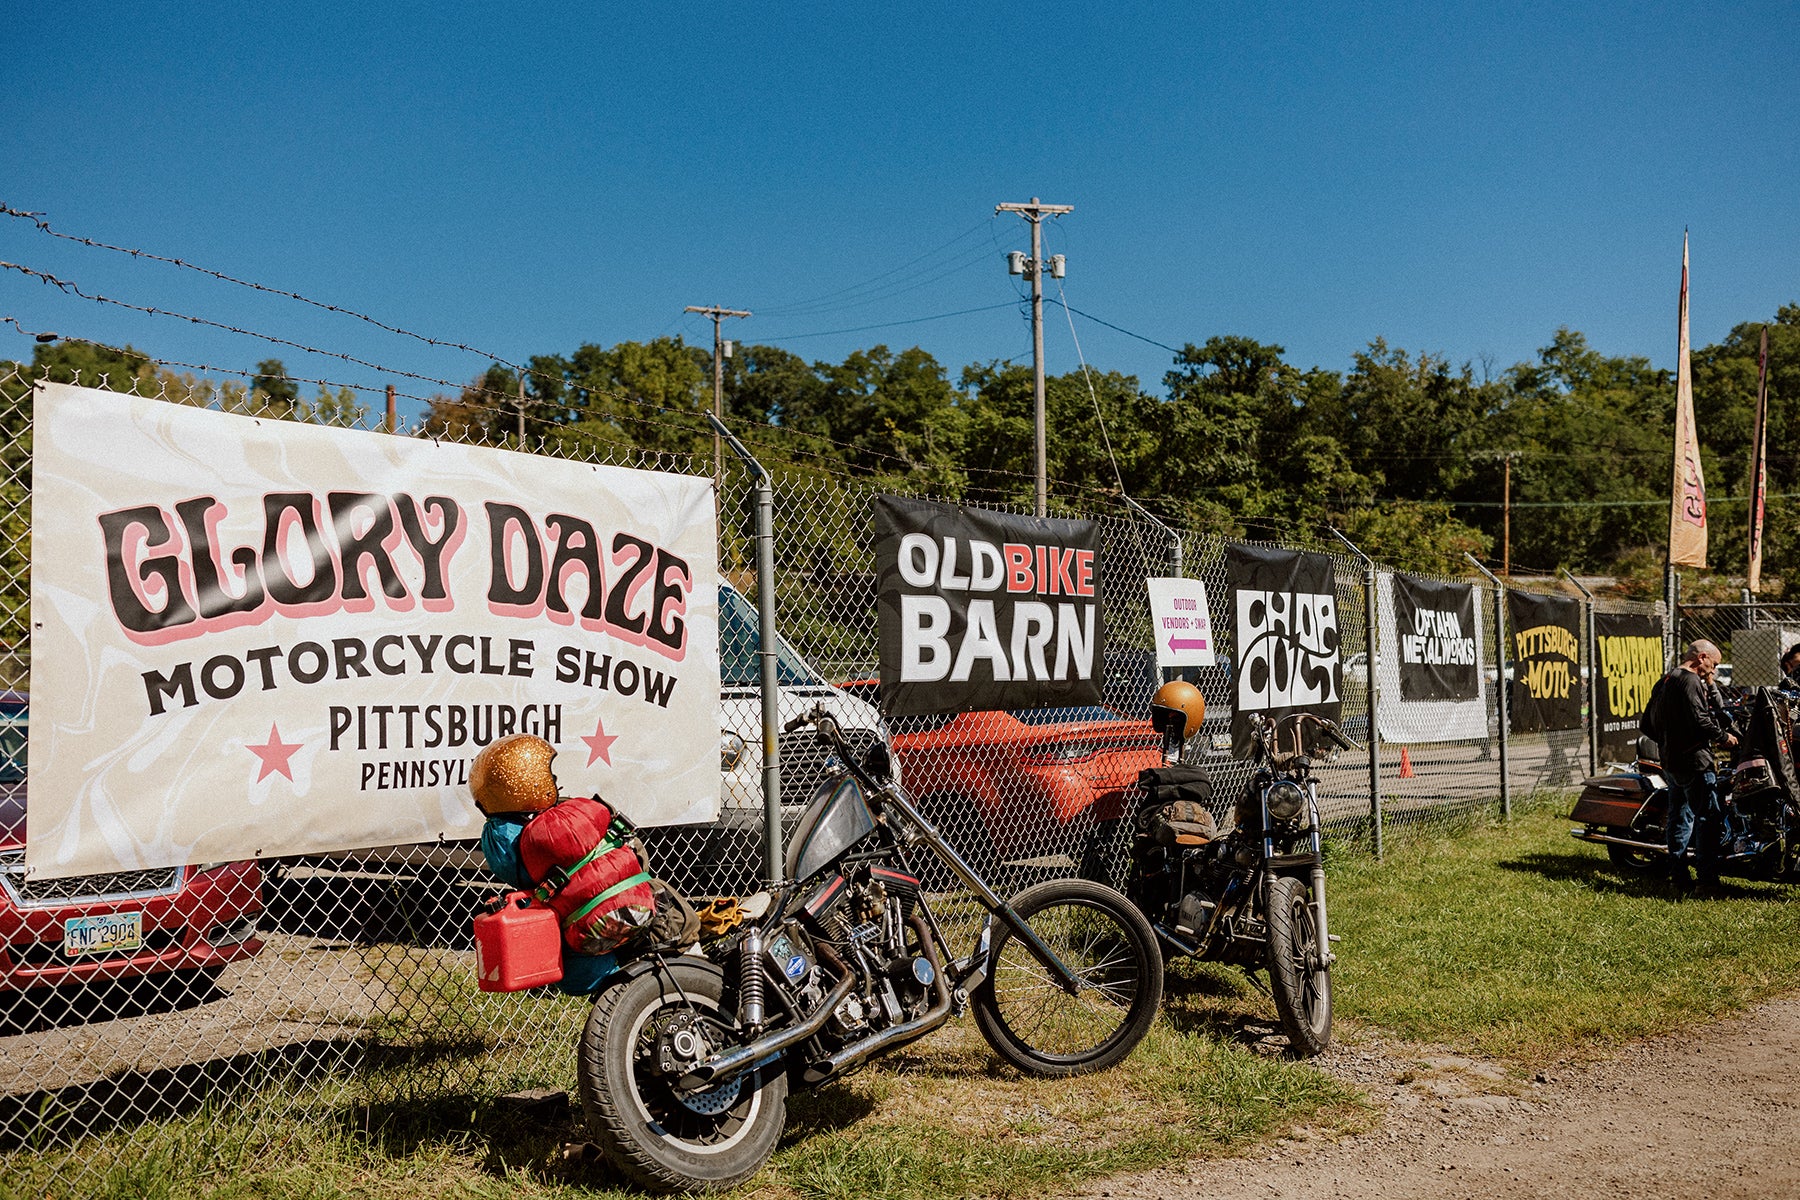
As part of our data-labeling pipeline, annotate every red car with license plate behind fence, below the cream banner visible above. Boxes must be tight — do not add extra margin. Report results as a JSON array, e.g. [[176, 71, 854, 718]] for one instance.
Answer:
[[0, 691, 263, 991]]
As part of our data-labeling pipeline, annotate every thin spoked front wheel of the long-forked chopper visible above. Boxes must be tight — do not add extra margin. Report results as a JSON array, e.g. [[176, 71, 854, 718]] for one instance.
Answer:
[[974, 880, 1163, 1076]]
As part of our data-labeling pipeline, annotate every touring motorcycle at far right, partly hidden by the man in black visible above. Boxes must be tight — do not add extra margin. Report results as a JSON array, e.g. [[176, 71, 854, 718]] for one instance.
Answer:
[[1570, 687, 1800, 880]]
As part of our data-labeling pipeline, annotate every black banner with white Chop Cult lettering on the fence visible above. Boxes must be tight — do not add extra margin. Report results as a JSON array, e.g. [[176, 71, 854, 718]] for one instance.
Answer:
[[1226, 543, 1343, 756]]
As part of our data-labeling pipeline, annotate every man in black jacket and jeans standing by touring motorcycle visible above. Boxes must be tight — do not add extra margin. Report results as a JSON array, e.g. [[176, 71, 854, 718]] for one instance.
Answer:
[[1645, 640, 1737, 887]]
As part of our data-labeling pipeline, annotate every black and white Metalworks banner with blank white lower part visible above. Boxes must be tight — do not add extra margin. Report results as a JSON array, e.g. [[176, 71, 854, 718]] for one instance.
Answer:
[[1375, 572, 1489, 745]]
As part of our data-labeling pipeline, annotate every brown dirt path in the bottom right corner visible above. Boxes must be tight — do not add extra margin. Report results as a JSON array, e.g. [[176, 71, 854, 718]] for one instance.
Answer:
[[1082, 995, 1800, 1200]]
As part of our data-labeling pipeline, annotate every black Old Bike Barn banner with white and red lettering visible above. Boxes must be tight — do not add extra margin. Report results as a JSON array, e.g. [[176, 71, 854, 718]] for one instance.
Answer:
[[873, 497, 1105, 716]]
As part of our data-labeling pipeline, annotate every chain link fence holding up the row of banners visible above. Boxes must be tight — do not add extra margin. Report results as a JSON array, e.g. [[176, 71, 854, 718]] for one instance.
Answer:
[[0, 372, 1670, 1196]]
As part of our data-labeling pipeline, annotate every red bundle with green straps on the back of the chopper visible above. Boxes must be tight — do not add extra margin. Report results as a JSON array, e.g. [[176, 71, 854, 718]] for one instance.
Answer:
[[518, 797, 657, 954]]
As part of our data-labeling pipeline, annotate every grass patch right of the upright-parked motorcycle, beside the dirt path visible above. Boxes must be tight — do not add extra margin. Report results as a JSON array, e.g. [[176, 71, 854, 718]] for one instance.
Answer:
[[1330, 801, 1800, 1065]]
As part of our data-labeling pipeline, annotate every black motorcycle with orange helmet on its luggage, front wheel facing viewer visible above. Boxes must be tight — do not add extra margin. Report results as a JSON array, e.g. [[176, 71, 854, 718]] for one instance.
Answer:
[[1125, 682, 1355, 1056]]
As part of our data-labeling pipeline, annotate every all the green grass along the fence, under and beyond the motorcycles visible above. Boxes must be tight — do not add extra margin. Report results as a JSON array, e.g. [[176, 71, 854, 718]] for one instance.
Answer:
[[0, 801, 1800, 1200]]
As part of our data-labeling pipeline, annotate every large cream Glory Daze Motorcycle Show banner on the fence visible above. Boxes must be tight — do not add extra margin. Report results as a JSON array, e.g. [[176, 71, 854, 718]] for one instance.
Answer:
[[25, 383, 720, 876]]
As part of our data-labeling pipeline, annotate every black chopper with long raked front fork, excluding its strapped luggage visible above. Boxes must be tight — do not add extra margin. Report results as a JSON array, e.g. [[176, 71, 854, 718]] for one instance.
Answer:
[[578, 709, 1163, 1191]]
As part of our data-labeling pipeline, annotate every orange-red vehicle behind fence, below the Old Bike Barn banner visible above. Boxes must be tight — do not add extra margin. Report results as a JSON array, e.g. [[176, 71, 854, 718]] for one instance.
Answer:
[[842, 680, 1163, 871]]
